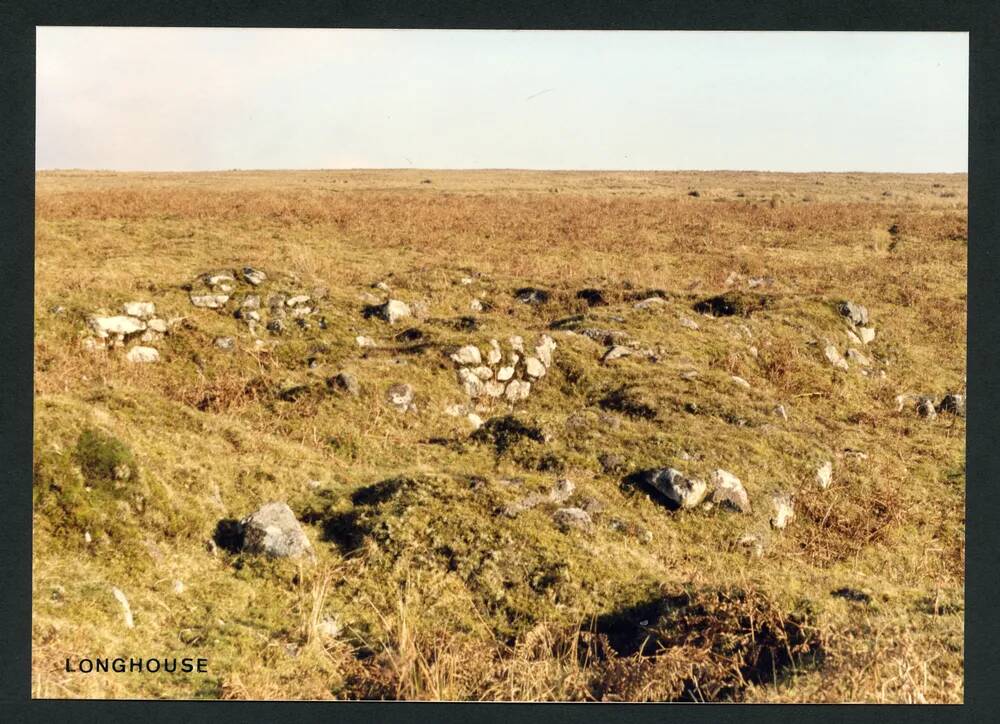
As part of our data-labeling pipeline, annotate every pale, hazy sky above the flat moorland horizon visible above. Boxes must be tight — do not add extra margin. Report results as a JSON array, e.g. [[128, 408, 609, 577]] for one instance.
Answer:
[[35, 27, 969, 172]]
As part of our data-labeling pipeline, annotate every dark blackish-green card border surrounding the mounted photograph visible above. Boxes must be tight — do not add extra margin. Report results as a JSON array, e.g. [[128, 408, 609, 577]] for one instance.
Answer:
[[0, 0, 1000, 722]]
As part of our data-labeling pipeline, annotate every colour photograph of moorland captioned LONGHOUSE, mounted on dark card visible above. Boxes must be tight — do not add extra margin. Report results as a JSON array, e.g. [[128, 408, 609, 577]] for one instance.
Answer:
[[33, 25, 979, 704]]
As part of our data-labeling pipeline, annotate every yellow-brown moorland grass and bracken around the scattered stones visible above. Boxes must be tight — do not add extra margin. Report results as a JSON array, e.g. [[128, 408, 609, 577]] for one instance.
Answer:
[[32, 171, 967, 703]]
